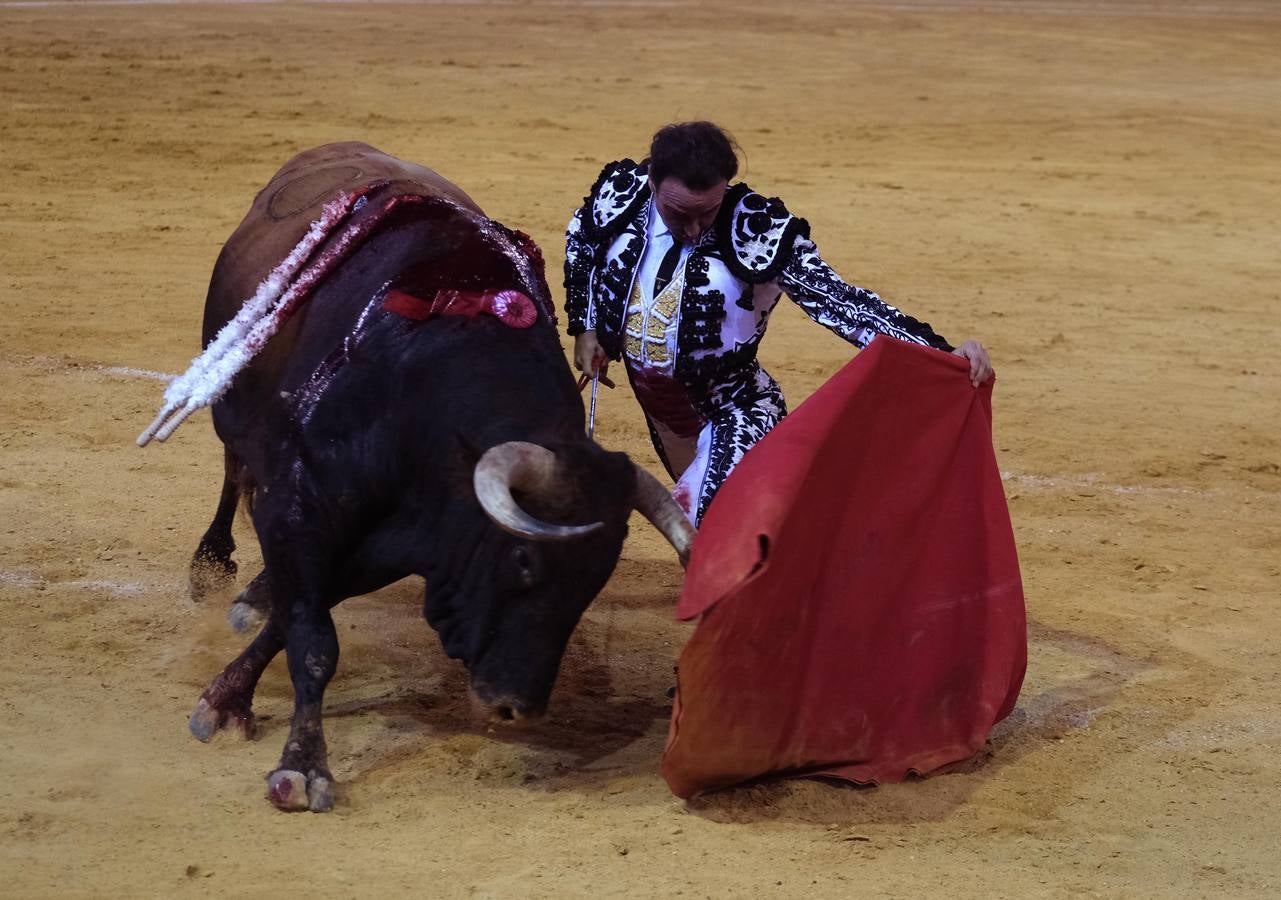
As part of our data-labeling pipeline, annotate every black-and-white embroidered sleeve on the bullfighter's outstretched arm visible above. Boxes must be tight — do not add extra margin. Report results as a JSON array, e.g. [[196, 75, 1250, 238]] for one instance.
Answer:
[[778, 236, 953, 352]]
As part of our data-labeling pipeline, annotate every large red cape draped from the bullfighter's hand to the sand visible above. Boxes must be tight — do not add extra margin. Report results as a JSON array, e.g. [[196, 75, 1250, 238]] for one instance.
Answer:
[[662, 338, 1027, 796]]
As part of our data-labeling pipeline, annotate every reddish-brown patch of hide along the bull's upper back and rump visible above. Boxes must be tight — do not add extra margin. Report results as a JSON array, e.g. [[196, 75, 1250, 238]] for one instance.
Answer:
[[202, 141, 483, 346]]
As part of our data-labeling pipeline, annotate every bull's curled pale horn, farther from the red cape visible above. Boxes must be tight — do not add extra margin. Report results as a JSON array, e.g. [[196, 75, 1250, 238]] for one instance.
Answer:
[[471, 440, 605, 540]]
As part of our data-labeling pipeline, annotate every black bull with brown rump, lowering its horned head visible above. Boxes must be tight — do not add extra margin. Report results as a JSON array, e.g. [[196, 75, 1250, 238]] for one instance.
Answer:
[[170, 143, 690, 810]]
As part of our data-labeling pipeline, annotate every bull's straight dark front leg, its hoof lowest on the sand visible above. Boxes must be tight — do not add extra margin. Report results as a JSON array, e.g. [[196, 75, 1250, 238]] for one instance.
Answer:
[[266, 602, 338, 813]]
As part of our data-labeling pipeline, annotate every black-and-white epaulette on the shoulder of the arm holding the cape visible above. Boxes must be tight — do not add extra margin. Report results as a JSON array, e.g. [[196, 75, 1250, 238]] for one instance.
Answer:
[[716, 184, 810, 284]]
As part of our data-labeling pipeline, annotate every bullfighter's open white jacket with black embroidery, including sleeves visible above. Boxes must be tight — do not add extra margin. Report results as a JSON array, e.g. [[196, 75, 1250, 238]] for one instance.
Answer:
[[565, 159, 952, 396]]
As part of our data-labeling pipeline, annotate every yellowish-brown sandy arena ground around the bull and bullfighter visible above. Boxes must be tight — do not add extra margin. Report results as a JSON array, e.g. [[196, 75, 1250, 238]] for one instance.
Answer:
[[0, 0, 1281, 897]]
